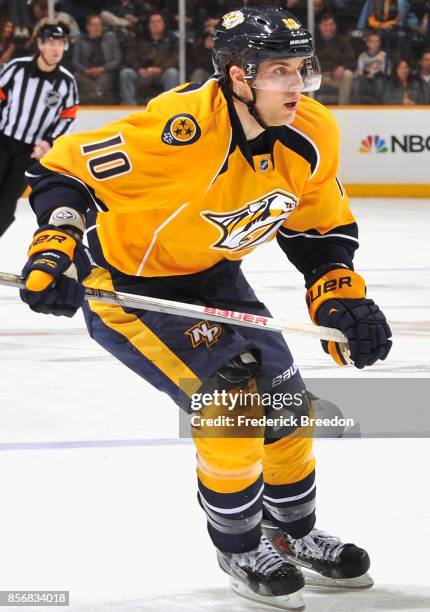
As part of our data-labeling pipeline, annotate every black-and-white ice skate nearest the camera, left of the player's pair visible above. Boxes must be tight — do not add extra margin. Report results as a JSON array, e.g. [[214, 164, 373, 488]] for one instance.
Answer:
[[217, 536, 305, 611]]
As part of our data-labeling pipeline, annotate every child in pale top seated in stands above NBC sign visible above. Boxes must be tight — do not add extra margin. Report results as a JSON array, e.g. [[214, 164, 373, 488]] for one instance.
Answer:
[[354, 32, 388, 104]]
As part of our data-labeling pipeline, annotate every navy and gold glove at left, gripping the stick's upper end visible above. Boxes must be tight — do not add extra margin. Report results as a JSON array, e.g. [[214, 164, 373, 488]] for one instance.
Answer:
[[20, 225, 91, 317]]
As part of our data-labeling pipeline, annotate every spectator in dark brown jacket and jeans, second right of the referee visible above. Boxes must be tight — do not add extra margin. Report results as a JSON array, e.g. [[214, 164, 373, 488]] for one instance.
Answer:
[[119, 13, 179, 105]]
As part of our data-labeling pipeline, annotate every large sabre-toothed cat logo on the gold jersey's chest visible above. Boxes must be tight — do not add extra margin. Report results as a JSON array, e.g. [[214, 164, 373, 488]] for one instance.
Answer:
[[201, 189, 298, 252]]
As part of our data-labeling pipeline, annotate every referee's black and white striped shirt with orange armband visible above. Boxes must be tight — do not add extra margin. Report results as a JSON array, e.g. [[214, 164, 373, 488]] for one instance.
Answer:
[[0, 57, 79, 144]]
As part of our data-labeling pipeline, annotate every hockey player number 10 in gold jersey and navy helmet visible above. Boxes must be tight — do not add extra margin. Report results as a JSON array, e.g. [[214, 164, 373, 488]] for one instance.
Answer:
[[21, 7, 391, 608]]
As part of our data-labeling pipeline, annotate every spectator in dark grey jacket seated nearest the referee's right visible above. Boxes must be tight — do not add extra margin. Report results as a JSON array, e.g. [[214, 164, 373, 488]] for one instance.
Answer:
[[72, 15, 121, 104]]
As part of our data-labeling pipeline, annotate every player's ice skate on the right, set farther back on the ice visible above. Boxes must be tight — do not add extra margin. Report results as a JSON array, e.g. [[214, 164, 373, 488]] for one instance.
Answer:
[[263, 521, 373, 589]]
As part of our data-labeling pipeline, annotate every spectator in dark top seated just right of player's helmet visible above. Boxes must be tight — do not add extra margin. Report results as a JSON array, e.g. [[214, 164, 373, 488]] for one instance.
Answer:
[[315, 13, 355, 104]]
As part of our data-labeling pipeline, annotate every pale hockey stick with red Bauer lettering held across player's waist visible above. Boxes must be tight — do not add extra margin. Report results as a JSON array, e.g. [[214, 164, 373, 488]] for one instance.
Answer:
[[0, 272, 348, 350]]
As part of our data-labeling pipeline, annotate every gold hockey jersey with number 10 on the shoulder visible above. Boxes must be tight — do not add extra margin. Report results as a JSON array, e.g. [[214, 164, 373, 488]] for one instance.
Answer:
[[41, 79, 356, 277]]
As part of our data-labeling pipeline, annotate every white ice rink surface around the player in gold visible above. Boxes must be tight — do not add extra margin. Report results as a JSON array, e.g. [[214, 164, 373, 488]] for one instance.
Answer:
[[0, 200, 430, 612]]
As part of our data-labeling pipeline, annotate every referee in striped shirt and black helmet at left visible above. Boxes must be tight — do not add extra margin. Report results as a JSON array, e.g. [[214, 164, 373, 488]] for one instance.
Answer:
[[0, 24, 79, 236]]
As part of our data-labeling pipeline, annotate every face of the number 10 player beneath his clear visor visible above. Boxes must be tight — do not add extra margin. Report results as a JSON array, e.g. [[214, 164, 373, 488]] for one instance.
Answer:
[[255, 58, 304, 126]]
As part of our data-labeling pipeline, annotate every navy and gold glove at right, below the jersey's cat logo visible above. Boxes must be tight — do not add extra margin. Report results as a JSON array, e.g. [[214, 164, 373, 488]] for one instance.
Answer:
[[306, 268, 392, 369]]
